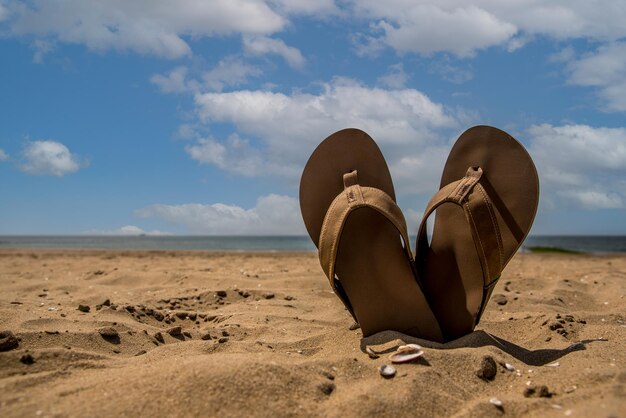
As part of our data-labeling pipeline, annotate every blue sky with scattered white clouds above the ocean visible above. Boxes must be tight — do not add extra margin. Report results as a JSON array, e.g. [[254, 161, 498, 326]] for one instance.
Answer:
[[0, 0, 626, 235]]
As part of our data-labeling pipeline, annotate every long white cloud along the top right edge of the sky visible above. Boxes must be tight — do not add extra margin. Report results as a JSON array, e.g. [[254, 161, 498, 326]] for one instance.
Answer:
[[351, 0, 626, 57]]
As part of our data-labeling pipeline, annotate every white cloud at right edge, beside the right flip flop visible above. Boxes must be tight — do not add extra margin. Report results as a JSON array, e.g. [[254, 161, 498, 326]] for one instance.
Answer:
[[528, 124, 626, 209]]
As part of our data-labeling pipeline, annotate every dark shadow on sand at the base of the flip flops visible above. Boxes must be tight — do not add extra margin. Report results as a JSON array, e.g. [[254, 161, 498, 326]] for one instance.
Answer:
[[361, 331, 607, 366]]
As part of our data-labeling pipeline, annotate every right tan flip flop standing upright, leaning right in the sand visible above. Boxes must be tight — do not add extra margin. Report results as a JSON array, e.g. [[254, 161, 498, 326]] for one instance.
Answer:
[[416, 126, 539, 341]]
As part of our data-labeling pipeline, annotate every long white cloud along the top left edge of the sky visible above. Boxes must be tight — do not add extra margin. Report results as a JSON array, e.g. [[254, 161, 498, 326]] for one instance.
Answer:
[[5, 0, 287, 58]]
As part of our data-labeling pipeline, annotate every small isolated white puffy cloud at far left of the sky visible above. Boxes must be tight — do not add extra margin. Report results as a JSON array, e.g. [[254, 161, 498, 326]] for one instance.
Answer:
[[20, 140, 84, 177]]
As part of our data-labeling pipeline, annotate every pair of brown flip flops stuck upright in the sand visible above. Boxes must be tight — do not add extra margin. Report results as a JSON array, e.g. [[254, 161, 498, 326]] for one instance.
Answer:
[[300, 126, 539, 342]]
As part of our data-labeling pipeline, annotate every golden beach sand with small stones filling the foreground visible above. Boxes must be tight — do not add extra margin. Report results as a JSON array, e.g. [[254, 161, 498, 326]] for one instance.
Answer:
[[0, 250, 626, 417]]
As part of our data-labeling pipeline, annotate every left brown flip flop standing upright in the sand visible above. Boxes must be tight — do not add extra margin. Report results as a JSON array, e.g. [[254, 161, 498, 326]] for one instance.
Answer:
[[300, 129, 442, 341]]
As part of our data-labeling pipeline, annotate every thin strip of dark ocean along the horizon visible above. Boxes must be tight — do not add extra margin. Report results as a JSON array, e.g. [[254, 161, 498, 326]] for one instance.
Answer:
[[0, 235, 626, 254]]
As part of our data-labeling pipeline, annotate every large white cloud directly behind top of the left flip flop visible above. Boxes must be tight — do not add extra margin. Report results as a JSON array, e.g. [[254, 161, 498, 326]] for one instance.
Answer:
[[187, 79, 457, 184]]
